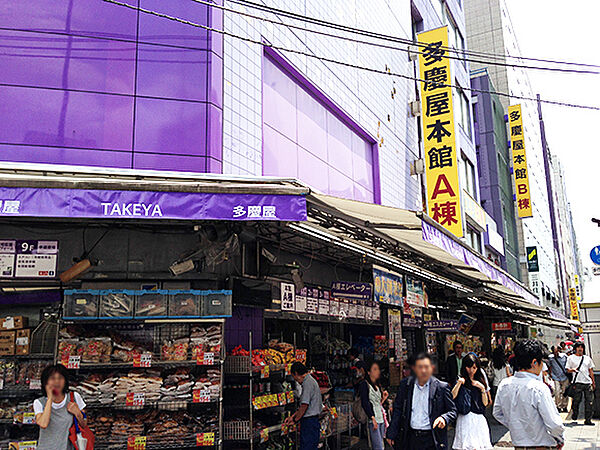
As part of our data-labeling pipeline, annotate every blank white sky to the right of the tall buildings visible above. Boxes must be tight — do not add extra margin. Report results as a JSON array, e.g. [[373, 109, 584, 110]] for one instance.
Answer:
[[506, 0, 600, 301]]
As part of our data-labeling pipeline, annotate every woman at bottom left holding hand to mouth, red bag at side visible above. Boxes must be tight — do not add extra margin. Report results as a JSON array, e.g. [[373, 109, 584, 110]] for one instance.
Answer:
[[33, 364, 87, 450]]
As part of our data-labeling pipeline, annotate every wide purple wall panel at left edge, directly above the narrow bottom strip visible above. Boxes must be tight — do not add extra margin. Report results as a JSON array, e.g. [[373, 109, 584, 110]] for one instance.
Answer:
[[0, 87, 133, 150]]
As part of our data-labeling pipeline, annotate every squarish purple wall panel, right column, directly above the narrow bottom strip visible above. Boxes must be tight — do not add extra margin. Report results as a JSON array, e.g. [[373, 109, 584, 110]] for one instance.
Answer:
[[134, 98, 206, 156]]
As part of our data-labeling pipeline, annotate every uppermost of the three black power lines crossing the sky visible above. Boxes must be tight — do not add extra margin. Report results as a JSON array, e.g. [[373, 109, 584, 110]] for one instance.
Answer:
[[229, 0, 600, 69]]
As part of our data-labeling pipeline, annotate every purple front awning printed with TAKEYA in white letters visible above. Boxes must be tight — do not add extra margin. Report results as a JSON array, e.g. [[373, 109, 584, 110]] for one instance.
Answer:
[[0, 165, 309, 221]]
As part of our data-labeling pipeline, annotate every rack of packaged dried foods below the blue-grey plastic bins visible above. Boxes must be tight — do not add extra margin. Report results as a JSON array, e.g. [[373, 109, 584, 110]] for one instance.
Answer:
[[56, 318, 225, 450]]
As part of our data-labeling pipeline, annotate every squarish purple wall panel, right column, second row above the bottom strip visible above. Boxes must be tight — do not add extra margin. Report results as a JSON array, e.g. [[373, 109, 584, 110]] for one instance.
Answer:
[[137, 44, 208, 101]]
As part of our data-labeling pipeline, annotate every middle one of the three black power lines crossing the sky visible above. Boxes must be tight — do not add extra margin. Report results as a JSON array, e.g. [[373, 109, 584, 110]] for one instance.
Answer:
[[186, 0, 600, 75]]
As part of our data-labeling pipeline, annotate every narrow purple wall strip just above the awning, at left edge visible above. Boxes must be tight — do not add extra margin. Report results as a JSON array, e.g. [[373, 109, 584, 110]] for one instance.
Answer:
[[0, 144, 131, 168]]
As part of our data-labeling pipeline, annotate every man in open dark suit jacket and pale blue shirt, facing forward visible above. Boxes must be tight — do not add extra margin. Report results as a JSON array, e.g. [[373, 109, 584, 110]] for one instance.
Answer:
[[386, 353, 456, 450]]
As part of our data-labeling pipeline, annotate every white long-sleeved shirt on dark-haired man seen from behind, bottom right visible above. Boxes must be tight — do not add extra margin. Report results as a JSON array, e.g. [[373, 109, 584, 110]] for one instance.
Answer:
[[494, 372, 565, 447]]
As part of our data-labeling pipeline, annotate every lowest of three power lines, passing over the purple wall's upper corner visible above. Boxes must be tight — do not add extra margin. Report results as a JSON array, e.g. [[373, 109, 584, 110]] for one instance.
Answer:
[[102, 0, 600, 111]]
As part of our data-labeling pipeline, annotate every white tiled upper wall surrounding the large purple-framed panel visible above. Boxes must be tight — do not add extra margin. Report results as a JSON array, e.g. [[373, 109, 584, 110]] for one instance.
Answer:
[[223, 0, 475, 210]]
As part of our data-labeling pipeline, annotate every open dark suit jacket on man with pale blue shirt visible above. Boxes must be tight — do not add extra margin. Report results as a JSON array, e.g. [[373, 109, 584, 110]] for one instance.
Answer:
[[386, 376, 456, 450]]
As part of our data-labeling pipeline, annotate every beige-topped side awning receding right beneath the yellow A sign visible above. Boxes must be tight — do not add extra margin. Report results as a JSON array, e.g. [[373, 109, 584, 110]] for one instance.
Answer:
[[308, 193, 548, 316]]
